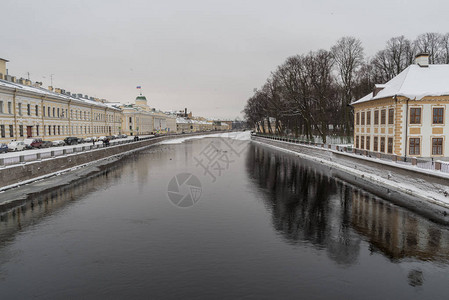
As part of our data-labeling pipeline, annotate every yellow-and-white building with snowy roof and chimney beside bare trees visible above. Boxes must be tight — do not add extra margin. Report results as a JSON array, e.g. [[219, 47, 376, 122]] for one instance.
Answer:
[[352, 54, 449, 158]]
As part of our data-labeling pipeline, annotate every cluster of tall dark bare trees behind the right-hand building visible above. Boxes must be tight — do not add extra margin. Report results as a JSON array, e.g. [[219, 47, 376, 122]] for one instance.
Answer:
[[244, 33, 449, 142]]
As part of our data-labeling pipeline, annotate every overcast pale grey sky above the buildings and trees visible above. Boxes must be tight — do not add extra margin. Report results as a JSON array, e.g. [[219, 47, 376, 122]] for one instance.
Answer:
[[0, 0, 449, 118]]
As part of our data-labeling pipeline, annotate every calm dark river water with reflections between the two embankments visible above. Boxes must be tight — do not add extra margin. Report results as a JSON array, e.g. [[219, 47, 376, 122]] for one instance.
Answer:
[[0, 138, 449, 299]]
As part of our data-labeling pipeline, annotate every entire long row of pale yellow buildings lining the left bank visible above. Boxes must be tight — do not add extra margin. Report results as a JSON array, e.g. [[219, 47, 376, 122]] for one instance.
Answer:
[[0, 58, 228, 143]]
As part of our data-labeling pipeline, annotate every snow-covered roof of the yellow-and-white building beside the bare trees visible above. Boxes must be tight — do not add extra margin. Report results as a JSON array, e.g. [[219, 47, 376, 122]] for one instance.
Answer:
[[352, 65, 449, 104]]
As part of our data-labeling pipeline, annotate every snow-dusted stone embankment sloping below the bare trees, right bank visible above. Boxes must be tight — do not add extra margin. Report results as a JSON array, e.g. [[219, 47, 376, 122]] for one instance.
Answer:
[[252, 136, 449, 224]]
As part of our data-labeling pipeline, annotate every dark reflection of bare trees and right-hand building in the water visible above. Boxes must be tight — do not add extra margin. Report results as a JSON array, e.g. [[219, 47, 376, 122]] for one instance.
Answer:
[[246, 144, 449, 264]]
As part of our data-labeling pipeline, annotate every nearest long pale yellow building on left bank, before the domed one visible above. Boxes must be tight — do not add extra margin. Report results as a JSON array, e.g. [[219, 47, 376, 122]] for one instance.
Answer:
[[0, 59, 122, 143]]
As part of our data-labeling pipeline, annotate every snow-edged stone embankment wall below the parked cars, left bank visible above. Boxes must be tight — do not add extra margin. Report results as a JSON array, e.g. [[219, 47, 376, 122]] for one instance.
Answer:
[[0, 132, 224, 192]]
